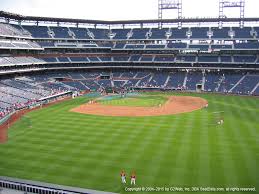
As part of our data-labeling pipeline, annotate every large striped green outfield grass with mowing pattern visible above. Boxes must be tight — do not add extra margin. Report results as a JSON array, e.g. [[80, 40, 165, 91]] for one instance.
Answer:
[[0, 94, 259, 193]]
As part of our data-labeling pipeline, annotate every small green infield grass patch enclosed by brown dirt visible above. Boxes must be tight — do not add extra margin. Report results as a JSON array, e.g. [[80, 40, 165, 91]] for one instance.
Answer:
[[98, 95, 167, 107]]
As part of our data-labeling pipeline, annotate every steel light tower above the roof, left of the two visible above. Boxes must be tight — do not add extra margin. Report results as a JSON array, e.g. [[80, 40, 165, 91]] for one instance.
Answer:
[[158, 0, 182, 27]]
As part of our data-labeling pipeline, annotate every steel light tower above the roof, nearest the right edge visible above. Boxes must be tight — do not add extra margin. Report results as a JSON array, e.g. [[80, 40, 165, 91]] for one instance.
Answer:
[[219, 0, 245, 28]]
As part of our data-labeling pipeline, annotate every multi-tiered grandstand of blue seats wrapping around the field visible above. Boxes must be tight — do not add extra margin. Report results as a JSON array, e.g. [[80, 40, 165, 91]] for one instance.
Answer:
[[0, 0, 259, 192]]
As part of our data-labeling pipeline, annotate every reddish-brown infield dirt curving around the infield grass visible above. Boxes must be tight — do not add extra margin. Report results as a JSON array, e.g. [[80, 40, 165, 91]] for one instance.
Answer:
[[71, 96, 208, 117]]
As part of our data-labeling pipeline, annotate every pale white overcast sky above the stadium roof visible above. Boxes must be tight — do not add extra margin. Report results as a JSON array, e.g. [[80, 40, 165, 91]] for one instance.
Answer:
[[0, 0, 259, 20]]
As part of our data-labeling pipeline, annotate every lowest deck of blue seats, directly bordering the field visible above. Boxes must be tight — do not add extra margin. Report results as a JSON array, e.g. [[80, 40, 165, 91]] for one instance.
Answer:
[[0, 70, 259, 117]]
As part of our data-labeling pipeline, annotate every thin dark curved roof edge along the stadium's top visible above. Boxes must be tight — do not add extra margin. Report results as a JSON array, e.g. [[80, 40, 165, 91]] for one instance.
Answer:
[[0, 11, 259, 25]]
